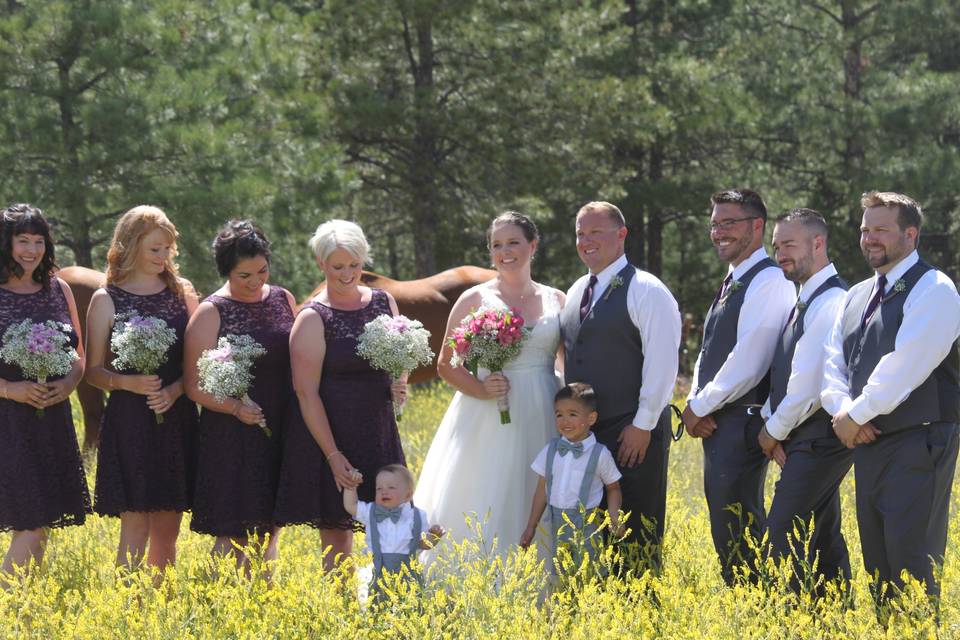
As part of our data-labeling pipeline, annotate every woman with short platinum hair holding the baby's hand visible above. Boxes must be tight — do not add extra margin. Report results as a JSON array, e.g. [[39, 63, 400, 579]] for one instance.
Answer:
[[276, 220, 407, 570]]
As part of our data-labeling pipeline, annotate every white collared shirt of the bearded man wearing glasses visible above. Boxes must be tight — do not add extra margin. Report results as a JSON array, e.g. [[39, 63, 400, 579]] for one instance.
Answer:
[[687, 247, 797, 418]]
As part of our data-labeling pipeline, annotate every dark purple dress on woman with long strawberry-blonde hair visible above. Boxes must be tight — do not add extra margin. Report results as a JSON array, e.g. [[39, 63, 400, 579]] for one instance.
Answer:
[[93, 285, 197, 516]]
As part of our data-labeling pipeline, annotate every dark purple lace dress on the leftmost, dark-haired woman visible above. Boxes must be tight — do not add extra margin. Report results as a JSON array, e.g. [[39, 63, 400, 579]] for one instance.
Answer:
[[0, 278, 90, 531]]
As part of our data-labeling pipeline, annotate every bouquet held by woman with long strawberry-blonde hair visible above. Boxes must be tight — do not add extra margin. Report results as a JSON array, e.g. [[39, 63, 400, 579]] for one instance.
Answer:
[[110, 311, 177, 424]]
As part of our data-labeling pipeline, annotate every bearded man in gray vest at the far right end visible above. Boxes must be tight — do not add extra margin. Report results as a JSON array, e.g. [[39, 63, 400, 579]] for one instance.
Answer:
[[820, 191, 960, 597]]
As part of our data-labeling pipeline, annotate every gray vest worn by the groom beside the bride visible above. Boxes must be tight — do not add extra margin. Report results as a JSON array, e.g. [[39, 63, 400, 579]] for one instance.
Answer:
[[560, 264, 643, 420]]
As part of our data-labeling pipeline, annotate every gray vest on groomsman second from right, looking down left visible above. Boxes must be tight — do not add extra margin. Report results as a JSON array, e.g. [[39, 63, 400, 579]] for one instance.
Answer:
[[770, 275, 848, 442]]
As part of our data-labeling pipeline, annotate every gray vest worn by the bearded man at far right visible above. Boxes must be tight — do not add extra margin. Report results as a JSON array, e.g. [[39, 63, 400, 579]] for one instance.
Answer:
[[842, 260, 960, 433]]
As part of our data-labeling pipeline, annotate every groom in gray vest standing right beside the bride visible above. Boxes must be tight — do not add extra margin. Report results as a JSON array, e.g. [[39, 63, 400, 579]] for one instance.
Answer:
[[560, 202, 680, 567]]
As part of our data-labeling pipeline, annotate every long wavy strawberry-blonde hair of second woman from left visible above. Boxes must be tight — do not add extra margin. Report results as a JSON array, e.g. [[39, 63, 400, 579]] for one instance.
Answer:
[[107, 204, 183, 296]]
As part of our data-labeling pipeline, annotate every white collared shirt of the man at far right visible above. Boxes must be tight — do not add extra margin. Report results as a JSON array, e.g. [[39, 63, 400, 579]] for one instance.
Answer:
[[820, 251, 960, 424]]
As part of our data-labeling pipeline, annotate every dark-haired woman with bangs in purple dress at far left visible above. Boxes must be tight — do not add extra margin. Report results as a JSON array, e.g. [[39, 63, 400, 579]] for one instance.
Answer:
[[0, 204, 90, 582]]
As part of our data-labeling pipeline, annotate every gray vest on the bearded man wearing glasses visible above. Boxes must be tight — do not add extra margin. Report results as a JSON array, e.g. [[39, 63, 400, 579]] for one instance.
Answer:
[[697, 258, 780, 406]]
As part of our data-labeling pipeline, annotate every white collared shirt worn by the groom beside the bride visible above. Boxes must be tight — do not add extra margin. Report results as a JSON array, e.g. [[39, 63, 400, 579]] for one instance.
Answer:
[[567, 256, 680, 431]]
